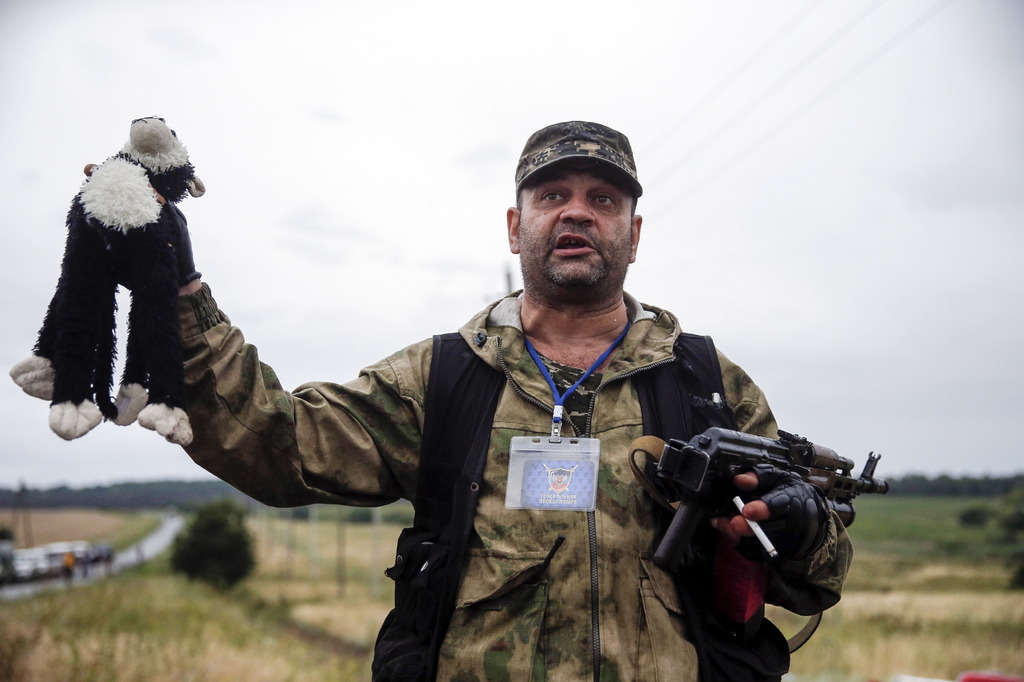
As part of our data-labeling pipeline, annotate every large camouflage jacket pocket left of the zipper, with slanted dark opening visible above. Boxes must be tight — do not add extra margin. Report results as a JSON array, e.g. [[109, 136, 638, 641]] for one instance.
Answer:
[[437, 550, 548, 682]]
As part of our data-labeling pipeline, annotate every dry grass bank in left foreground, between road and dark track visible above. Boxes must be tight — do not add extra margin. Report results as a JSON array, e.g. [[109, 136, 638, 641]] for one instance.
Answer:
[[0, 577, 366, 682]]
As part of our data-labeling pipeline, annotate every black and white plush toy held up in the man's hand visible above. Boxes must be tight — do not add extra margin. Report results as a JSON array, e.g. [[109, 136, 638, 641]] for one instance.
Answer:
[[10, 117, 205, 445]]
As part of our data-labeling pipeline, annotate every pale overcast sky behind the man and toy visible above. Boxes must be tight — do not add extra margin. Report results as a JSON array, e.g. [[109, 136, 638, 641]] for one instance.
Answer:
[[0, 0, 1024, 487]]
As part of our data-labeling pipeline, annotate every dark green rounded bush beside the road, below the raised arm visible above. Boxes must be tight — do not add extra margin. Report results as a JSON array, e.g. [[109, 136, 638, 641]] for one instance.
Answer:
[[171, 498, 256, 590]]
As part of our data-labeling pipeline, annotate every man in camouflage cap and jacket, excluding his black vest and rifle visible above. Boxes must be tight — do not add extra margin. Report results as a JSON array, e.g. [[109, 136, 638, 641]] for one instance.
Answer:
[[174, 122, 850, 681]]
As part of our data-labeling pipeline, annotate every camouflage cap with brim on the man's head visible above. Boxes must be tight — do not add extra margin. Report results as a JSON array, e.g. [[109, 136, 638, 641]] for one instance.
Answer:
[[515, 121, 643, 197]]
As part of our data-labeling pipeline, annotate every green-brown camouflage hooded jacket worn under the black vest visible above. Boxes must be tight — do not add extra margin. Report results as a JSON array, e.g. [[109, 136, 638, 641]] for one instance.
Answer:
[[180, 285, 852, 681]]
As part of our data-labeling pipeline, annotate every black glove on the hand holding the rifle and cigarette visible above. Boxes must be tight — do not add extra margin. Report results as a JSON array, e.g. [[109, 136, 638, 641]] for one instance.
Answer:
[[737, 464, 829, 561]]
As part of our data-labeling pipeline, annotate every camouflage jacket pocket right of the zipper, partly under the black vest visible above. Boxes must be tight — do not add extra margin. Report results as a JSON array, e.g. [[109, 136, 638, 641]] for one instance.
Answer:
[[637, 552, 697, 680]]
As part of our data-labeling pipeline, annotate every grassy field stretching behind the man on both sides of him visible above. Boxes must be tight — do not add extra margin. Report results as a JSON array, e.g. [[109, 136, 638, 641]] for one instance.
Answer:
[[0, 498, 1024, 682]]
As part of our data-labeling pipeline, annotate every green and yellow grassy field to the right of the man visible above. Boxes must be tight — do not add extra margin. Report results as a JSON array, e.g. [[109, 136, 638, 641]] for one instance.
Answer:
[[771, 497, 1024, 682]]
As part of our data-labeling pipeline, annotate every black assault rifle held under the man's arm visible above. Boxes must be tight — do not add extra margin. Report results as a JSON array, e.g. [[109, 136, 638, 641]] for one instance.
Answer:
[[654, 427, 889, 570]]
